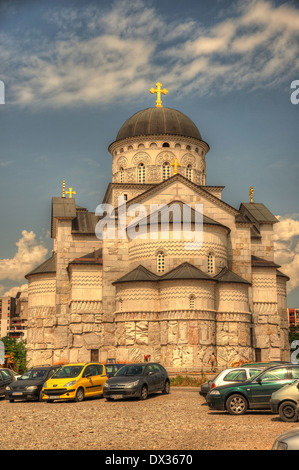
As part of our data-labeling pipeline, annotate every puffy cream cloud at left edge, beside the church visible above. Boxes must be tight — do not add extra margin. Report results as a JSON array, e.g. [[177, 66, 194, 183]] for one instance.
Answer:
[[0, 230, 48, 281]]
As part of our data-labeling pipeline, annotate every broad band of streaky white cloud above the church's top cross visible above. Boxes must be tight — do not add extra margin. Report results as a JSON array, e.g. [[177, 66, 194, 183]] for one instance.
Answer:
[[0, 0, 299, 107]]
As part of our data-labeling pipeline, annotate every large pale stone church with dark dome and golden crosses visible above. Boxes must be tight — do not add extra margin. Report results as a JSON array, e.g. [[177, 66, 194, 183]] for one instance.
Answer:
[[26, 83, 289, 372]]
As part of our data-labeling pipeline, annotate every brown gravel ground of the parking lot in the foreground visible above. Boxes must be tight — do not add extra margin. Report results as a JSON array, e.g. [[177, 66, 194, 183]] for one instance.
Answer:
[[0, 387, 299, 451]]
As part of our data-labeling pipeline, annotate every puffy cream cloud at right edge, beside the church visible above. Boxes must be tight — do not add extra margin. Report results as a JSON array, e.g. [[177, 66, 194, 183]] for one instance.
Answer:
[[274, 215, 299, 292]]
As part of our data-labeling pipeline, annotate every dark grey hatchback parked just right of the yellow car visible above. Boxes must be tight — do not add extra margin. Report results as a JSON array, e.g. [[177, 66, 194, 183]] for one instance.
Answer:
[[104, 363, 170, 401]]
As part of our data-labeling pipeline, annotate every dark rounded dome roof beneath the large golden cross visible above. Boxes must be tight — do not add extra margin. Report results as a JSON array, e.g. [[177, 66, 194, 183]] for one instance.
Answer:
[[116, 107, 202, 140]]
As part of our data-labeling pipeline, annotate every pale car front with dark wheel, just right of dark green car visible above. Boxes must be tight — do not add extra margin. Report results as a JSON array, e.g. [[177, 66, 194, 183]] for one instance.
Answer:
[[270, 380, 299, 422]]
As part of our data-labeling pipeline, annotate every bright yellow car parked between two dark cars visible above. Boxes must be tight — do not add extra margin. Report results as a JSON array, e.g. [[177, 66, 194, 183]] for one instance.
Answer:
[[42, 362, 108, 402]]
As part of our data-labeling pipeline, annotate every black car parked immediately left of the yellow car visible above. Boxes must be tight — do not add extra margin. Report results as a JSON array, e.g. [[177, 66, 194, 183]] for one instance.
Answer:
[[5, 366, 61, 402]]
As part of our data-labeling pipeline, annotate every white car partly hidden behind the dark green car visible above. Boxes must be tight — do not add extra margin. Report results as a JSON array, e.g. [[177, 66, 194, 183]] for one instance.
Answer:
[[199, 367, 263, 397]]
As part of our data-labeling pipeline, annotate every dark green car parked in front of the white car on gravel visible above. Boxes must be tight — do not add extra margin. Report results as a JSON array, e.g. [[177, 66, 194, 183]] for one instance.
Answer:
[[206, 363, 299, 415]]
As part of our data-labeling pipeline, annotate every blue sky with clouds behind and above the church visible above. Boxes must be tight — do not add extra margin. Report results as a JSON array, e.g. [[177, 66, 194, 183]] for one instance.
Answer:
[[0, 0, 299, 307]]
